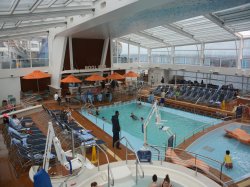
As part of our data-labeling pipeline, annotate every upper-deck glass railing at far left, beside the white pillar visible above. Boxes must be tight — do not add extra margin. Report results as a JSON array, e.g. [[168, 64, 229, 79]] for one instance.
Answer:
[[0, 57, 49, 69]]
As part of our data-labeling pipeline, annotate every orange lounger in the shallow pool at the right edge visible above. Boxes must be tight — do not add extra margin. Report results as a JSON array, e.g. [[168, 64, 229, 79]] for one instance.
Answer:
[[225, 128, 250, 144]]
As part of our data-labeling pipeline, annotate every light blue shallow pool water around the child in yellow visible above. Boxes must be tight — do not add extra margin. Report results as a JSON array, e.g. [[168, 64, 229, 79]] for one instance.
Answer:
[[187, 123, 250, 181]]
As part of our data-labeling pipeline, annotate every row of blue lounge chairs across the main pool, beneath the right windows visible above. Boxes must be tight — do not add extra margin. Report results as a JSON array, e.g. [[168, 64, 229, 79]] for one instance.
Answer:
[[152, 85, 236, 106]]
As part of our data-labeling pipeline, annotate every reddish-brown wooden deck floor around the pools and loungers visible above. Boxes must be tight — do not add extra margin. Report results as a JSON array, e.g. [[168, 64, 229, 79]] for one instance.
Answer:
[[0, 101, 248, 187]]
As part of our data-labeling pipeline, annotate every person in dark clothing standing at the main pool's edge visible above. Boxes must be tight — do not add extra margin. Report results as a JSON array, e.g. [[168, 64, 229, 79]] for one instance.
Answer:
[[111, 111, 121, 149]]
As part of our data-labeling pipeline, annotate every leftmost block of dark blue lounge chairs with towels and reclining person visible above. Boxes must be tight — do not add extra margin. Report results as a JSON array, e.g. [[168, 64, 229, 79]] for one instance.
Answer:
[[3, 117, 55, 176]]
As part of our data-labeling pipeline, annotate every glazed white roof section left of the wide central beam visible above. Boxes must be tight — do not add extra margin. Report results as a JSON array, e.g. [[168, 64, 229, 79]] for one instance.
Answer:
[[0, 0, 96, 38]]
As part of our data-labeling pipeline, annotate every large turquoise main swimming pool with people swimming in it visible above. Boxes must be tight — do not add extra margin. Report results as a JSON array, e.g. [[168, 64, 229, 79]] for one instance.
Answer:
[[82, 101, 221, 150]]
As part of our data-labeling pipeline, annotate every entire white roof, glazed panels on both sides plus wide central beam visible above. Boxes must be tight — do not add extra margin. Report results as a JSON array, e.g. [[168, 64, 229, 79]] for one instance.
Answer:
[[0, 0, 250, 48]]
